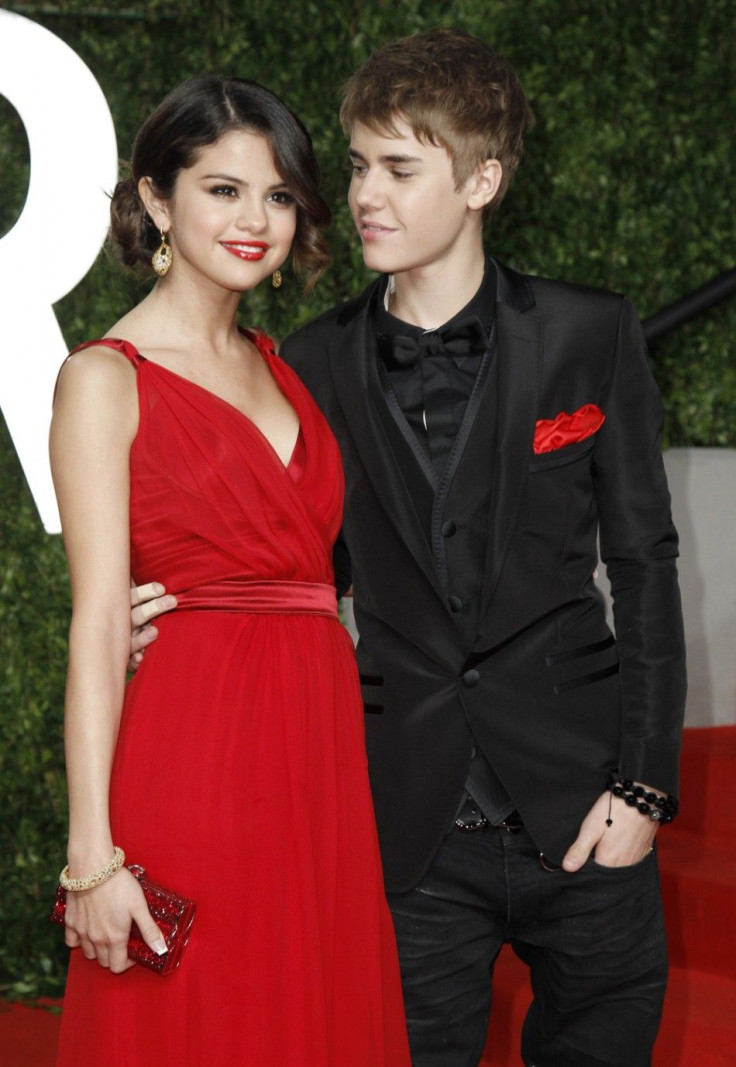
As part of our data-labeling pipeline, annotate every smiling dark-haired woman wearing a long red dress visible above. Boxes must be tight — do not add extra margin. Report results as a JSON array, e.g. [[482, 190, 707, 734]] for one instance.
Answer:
[[51, 76, 409, 1067]]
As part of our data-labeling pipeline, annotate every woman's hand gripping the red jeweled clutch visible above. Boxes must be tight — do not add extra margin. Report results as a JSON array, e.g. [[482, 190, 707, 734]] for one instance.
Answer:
[[66, 867, 166, 974]]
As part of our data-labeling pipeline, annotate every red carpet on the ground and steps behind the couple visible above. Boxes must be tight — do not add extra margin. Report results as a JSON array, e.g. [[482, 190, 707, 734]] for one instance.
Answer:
[[0, 727, 736, 1067]]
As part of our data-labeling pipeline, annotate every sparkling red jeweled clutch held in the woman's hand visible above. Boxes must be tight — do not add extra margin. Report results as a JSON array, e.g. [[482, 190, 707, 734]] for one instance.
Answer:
[[51, 864, 196, 974]]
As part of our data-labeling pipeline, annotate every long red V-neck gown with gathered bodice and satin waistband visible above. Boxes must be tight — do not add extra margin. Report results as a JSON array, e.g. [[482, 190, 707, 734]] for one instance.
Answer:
[[58, 334, 410, 1067]]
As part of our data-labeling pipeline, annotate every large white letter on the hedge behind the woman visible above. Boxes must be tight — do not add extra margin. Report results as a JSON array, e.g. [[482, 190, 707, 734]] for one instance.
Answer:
[[0, 10, 117, 534]]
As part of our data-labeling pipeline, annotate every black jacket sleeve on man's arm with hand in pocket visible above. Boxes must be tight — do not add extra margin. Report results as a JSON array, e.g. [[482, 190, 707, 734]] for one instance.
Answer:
[[593, 299, 686, 796]]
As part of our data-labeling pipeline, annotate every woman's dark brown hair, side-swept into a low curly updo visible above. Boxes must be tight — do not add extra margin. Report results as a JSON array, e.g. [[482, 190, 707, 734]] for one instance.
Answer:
[[110, 75, 332, 292]]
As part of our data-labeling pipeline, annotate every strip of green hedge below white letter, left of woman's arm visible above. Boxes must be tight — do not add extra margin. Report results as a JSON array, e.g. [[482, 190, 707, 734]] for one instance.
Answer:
[[0, 411, 69, 996]]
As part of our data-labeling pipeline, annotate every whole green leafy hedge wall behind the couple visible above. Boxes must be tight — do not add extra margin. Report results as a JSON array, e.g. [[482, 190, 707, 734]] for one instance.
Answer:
[[0, 0, 736, 996]]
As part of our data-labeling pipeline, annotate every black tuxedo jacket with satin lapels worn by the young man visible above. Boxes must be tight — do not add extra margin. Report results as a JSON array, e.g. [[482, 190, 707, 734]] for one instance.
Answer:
[[282, 264, 685, 892]]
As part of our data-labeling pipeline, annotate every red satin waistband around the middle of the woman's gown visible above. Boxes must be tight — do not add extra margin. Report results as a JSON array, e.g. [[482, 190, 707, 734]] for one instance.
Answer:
[[176, 579, 338, 619]]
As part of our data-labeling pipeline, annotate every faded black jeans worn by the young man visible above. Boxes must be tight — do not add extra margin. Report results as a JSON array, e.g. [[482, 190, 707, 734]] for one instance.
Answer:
[[388, 827, 667, 1067]]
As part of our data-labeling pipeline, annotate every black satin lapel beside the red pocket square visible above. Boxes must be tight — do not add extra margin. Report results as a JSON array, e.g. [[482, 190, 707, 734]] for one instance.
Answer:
[[481, 301, 542, 619]]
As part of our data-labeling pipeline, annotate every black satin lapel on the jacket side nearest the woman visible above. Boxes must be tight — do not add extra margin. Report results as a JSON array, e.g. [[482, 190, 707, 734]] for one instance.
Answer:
[[330, 310, 444, 596]]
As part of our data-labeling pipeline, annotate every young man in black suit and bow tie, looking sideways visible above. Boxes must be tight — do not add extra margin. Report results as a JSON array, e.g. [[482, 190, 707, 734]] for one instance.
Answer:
[[131, 30, 685, 1067]]
